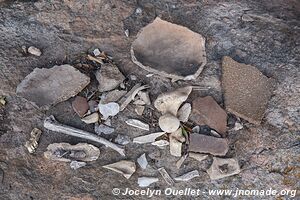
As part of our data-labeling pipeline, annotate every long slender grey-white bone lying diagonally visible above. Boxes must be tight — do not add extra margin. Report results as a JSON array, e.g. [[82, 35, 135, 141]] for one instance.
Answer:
[[44, 115, 125, 156]]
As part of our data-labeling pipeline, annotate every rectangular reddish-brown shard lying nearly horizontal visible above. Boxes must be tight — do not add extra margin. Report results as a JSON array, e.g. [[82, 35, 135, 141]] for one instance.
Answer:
[[189, 133, 229, 156]]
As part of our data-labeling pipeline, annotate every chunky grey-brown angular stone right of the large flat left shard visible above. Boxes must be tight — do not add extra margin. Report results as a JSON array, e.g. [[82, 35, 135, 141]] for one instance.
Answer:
[[95, 63, 125, 92]]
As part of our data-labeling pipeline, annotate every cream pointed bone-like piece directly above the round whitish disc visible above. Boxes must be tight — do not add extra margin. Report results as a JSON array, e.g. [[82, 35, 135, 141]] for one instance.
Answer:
[[154, 86, 193, 116]]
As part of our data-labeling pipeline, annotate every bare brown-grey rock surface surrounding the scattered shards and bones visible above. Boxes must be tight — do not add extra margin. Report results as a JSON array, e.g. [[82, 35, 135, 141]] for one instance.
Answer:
[[0, 0, 300, 199]]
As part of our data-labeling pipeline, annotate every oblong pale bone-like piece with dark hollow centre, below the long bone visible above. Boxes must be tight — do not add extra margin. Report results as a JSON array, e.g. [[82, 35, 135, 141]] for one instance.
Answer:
[[44, 143, 100, 162]]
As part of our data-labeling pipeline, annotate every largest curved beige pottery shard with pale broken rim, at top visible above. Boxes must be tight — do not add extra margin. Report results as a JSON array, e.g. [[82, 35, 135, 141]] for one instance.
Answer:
[[131, 17, 206, 80]]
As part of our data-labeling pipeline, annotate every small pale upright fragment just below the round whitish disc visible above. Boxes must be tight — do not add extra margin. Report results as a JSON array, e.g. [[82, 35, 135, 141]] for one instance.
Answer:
[[169, 128, 185, 157]]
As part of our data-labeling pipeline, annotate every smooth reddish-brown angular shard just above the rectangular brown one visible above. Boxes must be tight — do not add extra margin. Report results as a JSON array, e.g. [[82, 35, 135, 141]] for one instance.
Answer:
[[190, 96, 227, 135]]
